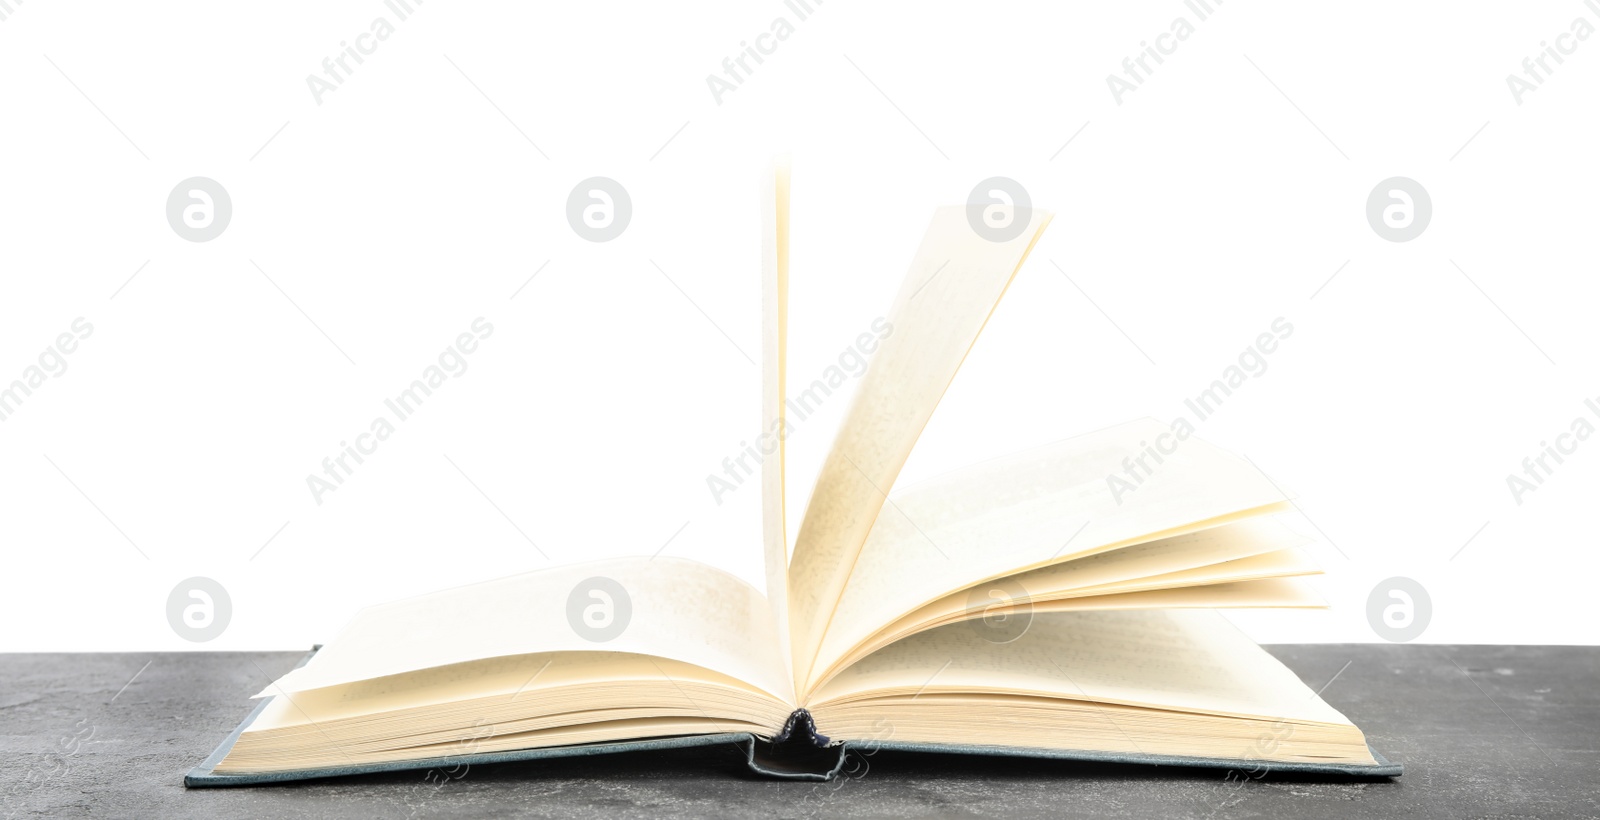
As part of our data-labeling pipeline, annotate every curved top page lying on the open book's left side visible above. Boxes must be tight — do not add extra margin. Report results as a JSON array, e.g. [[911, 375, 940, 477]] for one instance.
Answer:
[[258, 556, 794, 703]]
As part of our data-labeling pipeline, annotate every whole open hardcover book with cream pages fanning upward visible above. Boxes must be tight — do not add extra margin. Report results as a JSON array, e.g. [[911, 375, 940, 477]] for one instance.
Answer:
[[186, 163, 1400, 786]]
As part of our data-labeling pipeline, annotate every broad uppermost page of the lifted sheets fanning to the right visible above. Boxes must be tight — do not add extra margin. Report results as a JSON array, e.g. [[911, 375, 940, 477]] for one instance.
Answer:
[[802, 418, 1288, 689]]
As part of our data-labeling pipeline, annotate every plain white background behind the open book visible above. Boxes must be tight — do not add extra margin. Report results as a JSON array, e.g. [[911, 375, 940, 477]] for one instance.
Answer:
[[0, 0, 1600, 650]]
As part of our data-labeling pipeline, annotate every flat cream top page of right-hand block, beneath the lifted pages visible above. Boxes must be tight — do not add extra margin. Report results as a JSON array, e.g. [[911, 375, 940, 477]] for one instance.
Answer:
[[813, 610, 1349, 726]]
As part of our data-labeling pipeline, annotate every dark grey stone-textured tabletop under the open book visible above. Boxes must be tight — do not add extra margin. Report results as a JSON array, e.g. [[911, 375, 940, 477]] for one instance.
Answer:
[[0, 645, 1600, 820]]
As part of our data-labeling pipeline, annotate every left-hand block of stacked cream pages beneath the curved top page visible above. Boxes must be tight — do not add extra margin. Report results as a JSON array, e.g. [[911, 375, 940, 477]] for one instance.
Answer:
[[218, 652, 794, 772]]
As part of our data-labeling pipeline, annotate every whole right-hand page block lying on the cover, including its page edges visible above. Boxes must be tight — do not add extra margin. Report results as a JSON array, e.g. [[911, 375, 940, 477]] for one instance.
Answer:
[[811, 610, 1374, 766]]
